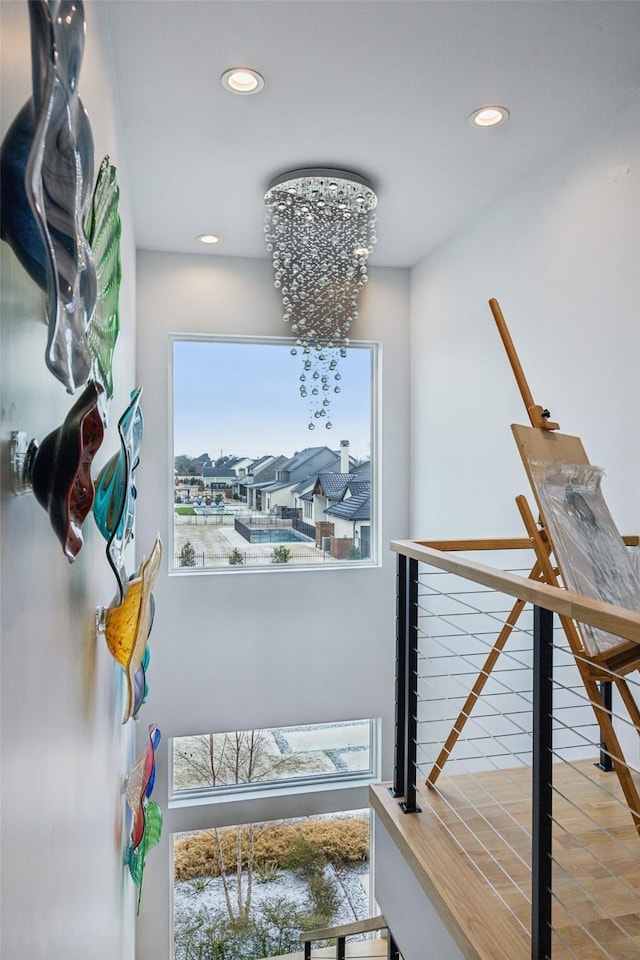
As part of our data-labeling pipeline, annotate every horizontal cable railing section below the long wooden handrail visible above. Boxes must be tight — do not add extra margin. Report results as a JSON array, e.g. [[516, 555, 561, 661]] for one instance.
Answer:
[[390, 553, 640, 960]]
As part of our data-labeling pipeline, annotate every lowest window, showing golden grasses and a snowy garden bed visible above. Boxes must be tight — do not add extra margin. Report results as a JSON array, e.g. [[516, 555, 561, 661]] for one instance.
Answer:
[[173, 810, 372, 960]]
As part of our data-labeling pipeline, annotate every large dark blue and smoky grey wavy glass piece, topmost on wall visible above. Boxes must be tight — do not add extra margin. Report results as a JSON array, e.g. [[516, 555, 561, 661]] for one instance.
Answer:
[[0, 0, 97, 393]]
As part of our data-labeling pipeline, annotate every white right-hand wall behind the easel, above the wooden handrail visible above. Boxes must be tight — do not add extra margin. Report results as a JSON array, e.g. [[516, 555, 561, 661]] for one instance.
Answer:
[[411, 104, 640, 537]]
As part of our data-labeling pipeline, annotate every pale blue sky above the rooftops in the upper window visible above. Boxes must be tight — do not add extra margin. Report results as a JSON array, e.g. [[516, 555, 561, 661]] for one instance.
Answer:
[[173, 340, 371, 459]]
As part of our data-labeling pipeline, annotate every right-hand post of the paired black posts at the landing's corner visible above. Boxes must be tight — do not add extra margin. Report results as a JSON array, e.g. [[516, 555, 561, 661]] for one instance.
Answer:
[[400, 560, 420, 813]]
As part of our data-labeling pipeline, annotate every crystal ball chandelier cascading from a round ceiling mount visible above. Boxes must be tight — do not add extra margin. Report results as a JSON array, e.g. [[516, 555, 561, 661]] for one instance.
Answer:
[[264, 167, 378, 430]]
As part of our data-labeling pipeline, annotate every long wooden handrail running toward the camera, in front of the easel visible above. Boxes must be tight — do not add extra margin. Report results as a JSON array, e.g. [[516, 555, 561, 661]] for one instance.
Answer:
[[389, 540, 640, 644]]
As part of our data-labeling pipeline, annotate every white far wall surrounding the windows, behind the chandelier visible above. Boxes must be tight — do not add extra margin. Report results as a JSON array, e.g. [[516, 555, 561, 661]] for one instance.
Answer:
[[136, 252, 409, 960]]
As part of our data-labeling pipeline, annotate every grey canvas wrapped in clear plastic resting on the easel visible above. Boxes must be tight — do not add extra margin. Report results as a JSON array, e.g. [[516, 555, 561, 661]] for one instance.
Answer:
[[530, 461, 640, 656]]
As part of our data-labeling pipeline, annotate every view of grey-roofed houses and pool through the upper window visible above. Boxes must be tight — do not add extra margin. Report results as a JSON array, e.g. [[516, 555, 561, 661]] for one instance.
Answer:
[[174, 440, 371, 567]]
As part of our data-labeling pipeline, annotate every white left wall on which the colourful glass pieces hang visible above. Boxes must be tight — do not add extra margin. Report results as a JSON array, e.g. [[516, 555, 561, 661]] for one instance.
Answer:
[[0, 0, 135, 960]]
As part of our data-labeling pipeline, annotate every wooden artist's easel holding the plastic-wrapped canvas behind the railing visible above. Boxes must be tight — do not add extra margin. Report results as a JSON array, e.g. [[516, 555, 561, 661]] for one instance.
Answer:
[[426, 300, 640, 834]]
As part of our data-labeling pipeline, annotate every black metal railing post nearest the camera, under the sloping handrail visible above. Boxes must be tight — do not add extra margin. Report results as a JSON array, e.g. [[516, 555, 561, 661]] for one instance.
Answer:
[[531, 606, 553, 960]]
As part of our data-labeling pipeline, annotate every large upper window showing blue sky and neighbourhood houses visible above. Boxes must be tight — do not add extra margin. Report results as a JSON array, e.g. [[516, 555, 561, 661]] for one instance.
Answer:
[[170, 336, 379, 573]]
